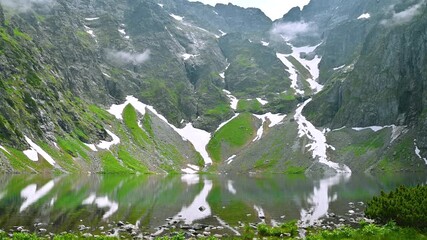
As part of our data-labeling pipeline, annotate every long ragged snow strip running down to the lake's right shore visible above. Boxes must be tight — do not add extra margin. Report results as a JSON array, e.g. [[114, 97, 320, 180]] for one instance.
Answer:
[[294, 98, 351, 173]]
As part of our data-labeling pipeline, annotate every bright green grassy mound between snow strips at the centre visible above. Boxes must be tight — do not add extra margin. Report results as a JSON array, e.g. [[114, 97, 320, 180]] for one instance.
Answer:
[[206, 113, 255, 162]]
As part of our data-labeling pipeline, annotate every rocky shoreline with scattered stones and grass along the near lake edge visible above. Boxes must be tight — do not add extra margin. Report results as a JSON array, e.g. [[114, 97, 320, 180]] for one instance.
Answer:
[[3, 202, 373, 239]]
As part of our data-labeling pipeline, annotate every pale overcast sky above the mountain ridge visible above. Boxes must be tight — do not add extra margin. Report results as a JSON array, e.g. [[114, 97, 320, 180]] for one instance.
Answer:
[[189, 0, 310, 20]]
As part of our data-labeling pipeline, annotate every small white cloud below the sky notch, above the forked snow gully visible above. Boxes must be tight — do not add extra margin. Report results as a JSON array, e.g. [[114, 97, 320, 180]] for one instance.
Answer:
[[270, 21, 317, 41]]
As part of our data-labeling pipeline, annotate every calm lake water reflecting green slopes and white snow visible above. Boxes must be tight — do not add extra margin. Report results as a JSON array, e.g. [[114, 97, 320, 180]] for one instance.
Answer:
[[0, 173, 427, 233]]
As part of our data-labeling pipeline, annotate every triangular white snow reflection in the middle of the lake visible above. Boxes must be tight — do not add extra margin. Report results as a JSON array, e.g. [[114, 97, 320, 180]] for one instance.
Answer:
[[173, 180, 212, 224]]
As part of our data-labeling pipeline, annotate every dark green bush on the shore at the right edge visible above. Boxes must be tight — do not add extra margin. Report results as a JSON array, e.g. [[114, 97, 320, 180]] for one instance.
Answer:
[[365, 186, 427, 229]]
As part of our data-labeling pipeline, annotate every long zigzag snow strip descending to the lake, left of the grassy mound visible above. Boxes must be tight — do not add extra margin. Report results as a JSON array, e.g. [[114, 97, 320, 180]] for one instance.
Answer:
[[107, 96, 212, 167]]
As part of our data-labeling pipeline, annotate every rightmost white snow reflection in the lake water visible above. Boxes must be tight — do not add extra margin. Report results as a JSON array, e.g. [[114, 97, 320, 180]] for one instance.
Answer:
[[301, 173, 351, 226]]
